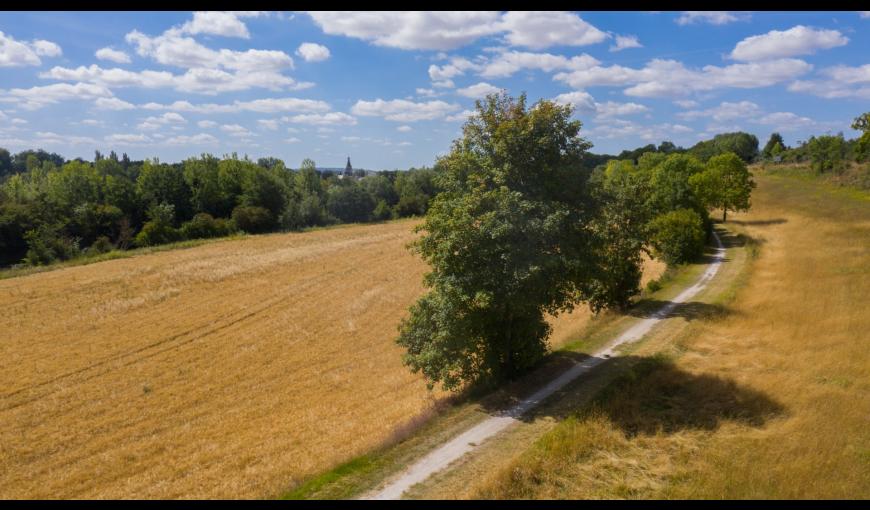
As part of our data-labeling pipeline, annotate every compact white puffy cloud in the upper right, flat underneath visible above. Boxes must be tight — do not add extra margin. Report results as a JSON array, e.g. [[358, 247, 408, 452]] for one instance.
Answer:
[[731, 25, 849, 61]]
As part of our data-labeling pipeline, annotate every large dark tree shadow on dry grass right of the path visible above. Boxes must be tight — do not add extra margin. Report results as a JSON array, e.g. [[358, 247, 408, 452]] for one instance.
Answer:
[[484, 353, 786, 437]]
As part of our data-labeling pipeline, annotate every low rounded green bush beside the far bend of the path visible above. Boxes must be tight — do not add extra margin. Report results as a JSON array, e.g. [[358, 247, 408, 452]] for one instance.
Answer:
[[650, 209, 706, 265]]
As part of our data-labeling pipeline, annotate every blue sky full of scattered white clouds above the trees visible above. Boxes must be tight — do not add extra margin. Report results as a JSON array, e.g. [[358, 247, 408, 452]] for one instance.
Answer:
[[0, 11, 870, 169]]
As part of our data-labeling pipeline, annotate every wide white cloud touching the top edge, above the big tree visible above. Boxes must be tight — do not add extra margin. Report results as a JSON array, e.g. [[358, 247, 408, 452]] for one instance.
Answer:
[[308, 11, 607, 50]]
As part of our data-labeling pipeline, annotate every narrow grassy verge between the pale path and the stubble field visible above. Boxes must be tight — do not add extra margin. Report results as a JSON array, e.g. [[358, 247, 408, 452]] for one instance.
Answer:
[[278, 238, 728, 499]]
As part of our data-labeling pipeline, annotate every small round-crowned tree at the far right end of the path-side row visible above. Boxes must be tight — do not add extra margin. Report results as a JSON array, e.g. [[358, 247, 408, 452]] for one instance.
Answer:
[[689, 152, 755, 221]]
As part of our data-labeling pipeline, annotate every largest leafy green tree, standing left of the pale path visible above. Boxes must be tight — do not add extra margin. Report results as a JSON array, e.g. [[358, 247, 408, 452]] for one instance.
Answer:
[[397, 95, 597, 389]]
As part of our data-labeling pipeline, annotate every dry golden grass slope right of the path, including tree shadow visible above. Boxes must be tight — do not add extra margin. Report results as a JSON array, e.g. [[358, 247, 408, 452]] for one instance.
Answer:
[[476, 175, 870, 498]]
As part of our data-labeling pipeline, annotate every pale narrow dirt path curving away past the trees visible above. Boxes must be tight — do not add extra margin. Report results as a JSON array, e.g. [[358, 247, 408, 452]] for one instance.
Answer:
[[361, 232, 725, 499]]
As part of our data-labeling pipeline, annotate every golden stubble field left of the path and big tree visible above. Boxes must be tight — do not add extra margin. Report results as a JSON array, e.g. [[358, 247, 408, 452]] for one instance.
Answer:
[[0, 217, 661, 498]]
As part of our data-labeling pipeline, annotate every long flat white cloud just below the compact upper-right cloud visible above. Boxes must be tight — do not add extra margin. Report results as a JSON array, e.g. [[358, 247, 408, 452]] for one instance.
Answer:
[[554, 59, 812, 97]]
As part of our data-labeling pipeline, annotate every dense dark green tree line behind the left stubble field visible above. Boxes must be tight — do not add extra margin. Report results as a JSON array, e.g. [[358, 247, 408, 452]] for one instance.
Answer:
[[0, 149, 438, 265]]
